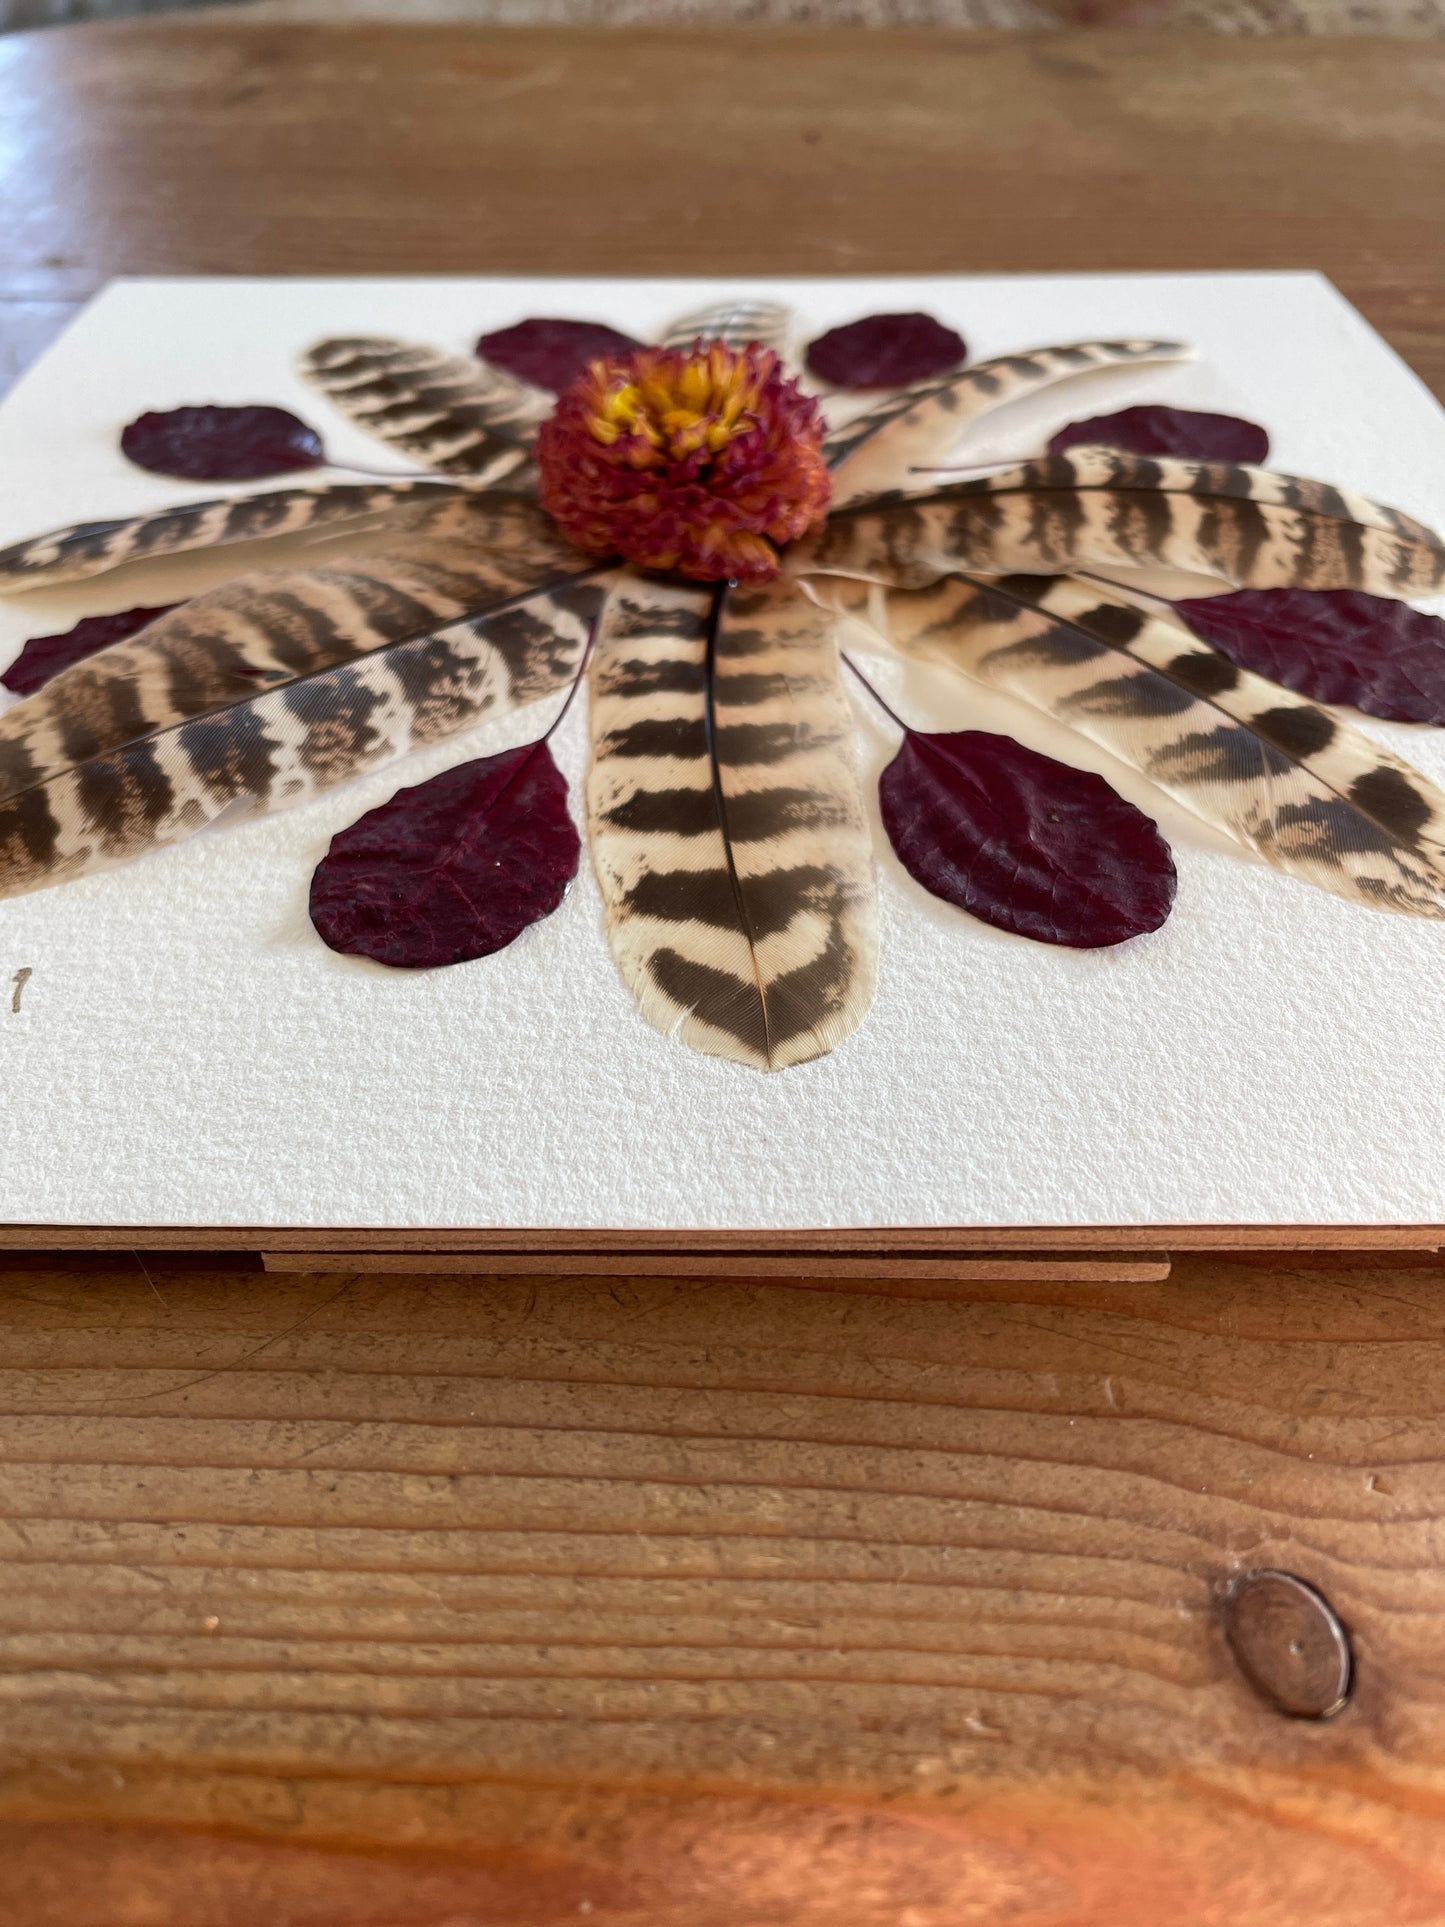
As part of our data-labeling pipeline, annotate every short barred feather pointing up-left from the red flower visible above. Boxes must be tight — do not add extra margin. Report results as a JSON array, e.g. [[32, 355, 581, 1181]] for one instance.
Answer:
[[299, 335, 553, 488]]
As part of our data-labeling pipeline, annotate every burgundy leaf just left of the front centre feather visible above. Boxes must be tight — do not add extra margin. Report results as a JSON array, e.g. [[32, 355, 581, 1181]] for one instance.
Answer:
[[310, 738, 580, 969]]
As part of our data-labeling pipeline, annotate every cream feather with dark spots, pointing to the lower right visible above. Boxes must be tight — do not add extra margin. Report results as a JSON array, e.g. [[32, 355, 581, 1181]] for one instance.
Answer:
[[827, 576, 1445, 917]]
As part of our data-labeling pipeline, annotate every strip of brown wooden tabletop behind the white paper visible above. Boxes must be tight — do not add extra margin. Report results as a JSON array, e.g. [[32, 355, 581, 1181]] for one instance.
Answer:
[[0, 15, 1445, 391]]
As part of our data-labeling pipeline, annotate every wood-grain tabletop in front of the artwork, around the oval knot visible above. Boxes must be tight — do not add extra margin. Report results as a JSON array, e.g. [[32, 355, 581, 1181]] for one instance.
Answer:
[[0, 1260, 1445, 1927]]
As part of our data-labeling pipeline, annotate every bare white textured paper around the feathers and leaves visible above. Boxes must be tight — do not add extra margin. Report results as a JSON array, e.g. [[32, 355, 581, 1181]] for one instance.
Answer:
[[0, 274, 1445, 1229]]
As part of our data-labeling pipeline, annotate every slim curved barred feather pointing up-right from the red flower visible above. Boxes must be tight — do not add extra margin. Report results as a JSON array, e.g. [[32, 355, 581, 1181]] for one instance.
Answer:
[[823, 341, 1193, 507]]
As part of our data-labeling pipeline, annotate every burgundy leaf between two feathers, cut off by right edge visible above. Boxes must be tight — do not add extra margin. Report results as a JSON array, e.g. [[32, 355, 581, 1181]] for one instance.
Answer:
[[1173, 590, 1445, 723]]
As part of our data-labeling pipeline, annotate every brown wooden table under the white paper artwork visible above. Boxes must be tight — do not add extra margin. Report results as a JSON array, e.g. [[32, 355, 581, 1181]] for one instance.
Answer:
[[0, 17, 1445, 1927]]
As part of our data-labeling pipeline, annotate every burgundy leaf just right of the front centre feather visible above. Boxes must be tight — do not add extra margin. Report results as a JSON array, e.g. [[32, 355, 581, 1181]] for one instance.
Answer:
[[879, 728, 1175, 950]]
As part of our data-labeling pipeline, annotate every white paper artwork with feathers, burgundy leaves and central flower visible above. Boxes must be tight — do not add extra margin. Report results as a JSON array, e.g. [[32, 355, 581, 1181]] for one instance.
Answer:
[[0, 277, 1445, 1224]]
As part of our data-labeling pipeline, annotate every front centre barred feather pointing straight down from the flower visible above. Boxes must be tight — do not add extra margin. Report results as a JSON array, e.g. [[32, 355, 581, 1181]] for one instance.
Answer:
[[588, 578, 877, 1069]]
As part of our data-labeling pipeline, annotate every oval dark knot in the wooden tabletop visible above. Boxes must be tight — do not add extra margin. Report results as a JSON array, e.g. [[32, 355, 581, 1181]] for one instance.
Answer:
[[1223, 1567, 1354, 1719]]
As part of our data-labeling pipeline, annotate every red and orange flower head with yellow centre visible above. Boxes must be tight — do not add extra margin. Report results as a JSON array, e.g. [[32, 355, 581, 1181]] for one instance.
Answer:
[[538, 341, 832, 582]]
